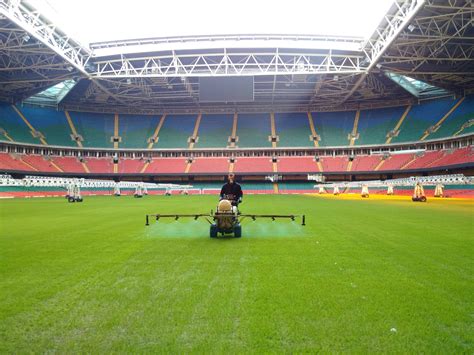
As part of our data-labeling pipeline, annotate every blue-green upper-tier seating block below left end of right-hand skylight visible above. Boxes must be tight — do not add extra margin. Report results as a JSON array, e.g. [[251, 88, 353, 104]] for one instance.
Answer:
[[355, 107, 406, 145]]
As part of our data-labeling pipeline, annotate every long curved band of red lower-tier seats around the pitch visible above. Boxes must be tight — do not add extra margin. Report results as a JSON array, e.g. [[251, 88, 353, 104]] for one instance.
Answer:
[[0, 147, 474, 175]]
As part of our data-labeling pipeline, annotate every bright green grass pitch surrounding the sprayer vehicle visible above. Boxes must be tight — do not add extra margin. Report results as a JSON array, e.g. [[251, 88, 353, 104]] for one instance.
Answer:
[[0, 196, 474, 353]]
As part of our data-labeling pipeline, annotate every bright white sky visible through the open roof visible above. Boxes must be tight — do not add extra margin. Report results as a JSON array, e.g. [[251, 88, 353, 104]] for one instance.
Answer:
[[28, 0, 393, 46]]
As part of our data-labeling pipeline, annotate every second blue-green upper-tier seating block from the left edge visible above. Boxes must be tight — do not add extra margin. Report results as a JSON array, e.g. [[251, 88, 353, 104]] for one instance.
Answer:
[[19, 107, 77, 147]]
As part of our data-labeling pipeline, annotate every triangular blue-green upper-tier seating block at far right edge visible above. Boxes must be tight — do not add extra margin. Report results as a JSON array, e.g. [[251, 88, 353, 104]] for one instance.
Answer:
[[427, 95, 474, 139]]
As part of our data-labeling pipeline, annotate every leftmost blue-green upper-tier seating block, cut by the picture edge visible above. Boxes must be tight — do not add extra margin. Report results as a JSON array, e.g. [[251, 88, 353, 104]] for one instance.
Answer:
[[0, 105, 41, 144]]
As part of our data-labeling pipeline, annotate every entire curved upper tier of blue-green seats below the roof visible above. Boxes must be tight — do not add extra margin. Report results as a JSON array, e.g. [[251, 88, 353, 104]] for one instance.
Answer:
[[0, 95, 474, 149]]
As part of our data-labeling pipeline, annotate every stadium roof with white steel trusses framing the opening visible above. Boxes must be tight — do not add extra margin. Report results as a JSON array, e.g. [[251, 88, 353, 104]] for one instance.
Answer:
[[0, 0, 474, 112]]
